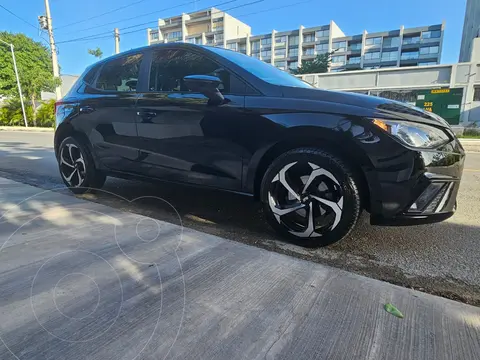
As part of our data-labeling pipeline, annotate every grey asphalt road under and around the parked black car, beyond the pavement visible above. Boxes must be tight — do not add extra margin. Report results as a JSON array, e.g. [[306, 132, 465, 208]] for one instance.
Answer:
[[0, 132, 480, 306]]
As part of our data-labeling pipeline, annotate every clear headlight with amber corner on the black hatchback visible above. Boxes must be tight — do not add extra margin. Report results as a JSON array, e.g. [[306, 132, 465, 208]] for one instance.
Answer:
[[373, 119, 450, 148]]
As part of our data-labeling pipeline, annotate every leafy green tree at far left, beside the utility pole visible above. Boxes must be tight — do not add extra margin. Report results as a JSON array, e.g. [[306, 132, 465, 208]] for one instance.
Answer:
[[0, 32, 61, 125]]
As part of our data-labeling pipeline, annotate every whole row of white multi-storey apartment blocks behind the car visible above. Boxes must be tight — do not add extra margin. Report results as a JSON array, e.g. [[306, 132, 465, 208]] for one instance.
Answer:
[[148, 8, 445, 71]]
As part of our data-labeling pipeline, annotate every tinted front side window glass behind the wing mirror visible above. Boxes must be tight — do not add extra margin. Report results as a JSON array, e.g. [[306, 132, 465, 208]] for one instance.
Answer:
[[149, 50, 231, 93]]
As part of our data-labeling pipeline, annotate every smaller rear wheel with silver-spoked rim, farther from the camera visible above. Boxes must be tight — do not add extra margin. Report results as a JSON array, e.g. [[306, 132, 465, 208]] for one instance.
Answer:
[[57, 136, 106, 194]]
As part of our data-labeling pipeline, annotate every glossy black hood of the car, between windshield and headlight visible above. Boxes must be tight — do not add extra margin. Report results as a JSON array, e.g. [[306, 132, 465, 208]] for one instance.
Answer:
[[283, 87, 450, 127]]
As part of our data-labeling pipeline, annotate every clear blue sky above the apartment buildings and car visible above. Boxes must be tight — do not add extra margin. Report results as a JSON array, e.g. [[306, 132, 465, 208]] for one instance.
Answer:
[[0, 0, 466, 75]]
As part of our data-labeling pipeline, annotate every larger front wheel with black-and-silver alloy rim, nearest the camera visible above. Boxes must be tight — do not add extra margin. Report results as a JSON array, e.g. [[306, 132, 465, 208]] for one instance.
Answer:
[[260, 148, 361, 248]]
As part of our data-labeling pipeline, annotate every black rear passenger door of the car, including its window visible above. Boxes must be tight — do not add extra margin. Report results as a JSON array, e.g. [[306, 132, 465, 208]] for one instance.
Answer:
[[76, 53, 143, 172]]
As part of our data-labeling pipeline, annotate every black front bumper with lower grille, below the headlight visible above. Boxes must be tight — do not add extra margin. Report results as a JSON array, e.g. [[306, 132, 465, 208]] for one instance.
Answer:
[[370, 139, 465, 226]]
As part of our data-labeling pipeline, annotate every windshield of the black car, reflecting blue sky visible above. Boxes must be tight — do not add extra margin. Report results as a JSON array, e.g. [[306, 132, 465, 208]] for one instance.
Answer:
[[207, 46, 313, 88]]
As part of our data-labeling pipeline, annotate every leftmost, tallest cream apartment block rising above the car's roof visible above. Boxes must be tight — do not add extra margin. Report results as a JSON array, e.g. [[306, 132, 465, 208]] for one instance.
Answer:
[[147, 8, 251, 47]]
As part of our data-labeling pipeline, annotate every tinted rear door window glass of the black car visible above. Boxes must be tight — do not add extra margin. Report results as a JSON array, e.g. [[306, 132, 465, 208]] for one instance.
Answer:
[[95, 54, 142, 92]]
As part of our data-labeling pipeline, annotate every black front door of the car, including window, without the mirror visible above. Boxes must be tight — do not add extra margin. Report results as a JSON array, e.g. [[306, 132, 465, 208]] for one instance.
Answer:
[[137, 48, 246, 190]]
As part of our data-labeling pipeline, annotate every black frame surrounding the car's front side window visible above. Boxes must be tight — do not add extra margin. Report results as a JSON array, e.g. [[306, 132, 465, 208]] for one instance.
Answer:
[[144, 46, 253, 96]]
